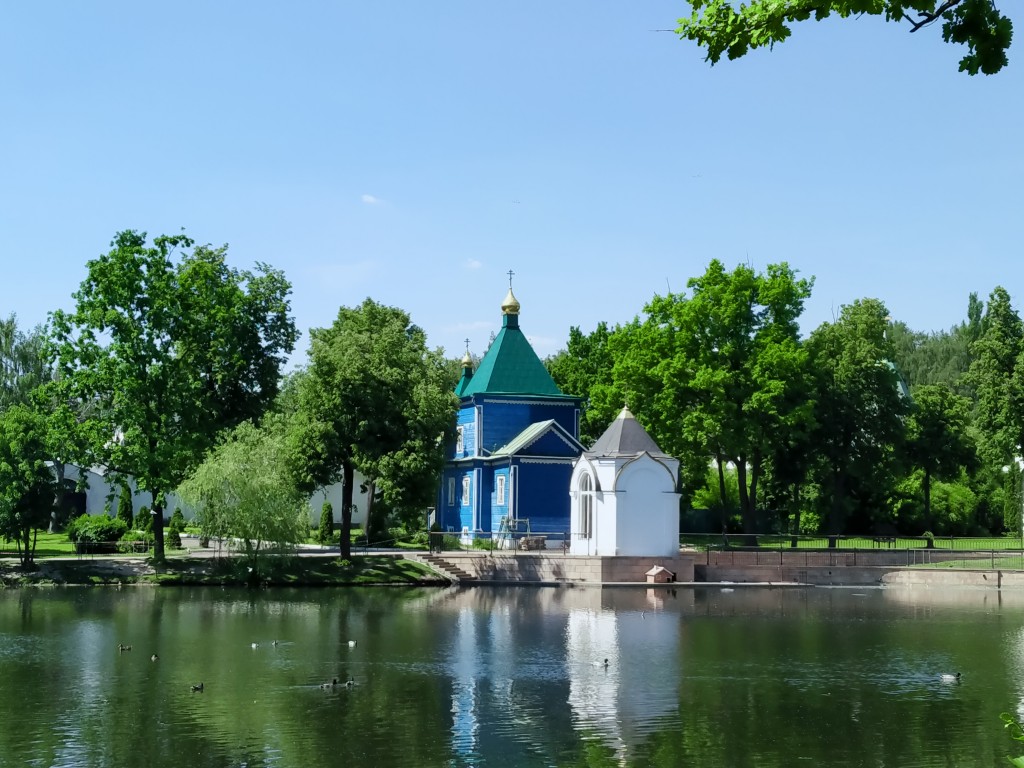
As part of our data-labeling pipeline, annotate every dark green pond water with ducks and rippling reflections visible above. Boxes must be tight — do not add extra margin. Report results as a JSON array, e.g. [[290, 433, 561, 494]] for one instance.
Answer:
[[0, 587, 1024, 768]]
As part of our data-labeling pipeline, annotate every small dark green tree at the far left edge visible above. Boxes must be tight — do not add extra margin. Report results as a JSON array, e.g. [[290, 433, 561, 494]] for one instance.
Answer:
[[0, 404, 55, 566]]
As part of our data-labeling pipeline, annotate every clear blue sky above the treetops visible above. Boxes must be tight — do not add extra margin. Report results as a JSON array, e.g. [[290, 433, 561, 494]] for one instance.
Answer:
[[0, 0, 1024, 370]]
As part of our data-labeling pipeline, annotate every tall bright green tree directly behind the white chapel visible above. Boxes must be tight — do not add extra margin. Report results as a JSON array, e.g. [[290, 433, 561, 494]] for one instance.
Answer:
[[615, 259, 813, 532]]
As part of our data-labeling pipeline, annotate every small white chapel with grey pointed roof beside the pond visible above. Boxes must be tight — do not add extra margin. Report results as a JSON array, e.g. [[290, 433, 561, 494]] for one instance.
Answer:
[[569, 408, 679, 557]]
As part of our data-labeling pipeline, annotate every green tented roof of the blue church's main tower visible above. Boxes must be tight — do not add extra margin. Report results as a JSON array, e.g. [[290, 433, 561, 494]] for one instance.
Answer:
[[459, 314, 564, 397]]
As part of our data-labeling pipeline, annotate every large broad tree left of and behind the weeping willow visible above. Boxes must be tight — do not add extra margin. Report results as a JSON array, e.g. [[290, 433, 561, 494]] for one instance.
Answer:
[[51, 230, 298, 560]]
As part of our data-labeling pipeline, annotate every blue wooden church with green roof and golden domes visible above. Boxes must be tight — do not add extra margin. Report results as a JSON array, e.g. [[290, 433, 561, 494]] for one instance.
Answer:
[[437, 288, 584, 547]]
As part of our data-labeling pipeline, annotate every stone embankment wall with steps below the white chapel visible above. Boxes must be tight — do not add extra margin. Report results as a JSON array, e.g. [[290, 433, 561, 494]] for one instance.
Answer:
[[441, 552, 693, 584]]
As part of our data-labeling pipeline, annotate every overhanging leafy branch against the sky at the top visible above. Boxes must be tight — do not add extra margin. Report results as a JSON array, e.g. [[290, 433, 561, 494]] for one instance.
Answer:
[[676, 0, 1013, 75]]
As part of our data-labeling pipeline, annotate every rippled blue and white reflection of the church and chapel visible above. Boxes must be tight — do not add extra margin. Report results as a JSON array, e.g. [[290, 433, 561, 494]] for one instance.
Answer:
[[440, 587, 692, 765]]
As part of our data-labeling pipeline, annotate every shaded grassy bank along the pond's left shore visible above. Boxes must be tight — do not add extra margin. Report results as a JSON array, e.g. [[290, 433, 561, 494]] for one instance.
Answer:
[[0, 555, 446, 587]]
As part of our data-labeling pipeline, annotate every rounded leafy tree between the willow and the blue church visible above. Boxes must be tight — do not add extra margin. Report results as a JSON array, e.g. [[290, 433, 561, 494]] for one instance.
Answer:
[[292, 299, 458, 557]]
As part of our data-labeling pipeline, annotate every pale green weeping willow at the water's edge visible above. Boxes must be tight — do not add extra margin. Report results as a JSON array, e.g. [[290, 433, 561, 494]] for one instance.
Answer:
[[178, 419, 309, 579]]
